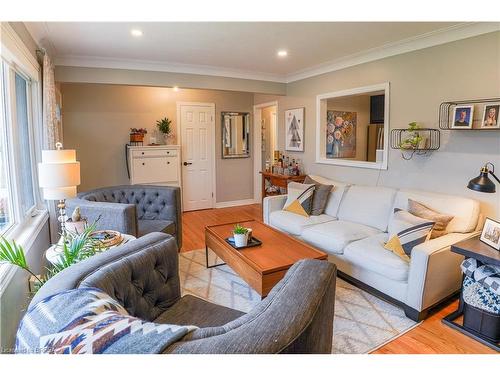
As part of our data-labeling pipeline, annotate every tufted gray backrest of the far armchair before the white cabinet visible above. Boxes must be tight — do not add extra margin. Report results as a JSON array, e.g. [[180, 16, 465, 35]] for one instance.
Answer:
[[78, 185, 178, 220]]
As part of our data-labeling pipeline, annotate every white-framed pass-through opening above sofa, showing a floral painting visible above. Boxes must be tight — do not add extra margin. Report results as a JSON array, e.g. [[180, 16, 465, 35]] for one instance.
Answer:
[[316, 82, 389, 169]]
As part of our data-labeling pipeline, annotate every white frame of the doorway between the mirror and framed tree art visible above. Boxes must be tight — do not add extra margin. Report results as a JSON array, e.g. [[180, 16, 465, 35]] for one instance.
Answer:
[[253, 100, 279, 203]]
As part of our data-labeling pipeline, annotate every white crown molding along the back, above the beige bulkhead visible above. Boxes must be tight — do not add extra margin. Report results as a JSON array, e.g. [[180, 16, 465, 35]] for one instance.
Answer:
[[54, 55, 286, 83]]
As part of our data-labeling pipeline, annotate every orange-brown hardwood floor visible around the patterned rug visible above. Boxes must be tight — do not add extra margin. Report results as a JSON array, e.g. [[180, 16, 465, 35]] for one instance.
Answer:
[[181, 204, 495, 354]]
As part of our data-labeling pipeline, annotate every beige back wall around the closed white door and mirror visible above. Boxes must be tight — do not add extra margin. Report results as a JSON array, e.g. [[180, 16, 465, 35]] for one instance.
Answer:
[[61, 83, 253, 202]]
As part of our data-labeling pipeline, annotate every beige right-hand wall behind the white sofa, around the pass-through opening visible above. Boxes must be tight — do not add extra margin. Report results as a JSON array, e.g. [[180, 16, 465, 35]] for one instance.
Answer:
[[255, 32, 500, 218]]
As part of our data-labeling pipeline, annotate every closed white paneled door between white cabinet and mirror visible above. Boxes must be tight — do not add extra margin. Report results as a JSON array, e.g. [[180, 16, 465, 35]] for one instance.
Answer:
[[180, 104, 215, 211]]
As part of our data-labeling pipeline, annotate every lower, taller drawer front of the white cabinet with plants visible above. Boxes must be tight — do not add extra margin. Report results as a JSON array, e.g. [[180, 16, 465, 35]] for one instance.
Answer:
[[132, 157, 179, 184]]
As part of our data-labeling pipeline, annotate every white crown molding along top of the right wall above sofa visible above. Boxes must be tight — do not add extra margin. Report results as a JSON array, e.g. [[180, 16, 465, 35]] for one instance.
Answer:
[[286, 22, 500, 83]]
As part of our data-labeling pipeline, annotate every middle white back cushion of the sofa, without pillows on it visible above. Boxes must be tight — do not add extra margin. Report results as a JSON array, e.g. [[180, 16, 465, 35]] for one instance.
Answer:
[[338, 185, 396, 232]]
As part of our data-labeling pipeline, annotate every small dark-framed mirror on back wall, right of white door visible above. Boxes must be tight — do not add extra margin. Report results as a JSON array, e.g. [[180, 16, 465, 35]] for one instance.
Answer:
[[221, 112, 250, 159]]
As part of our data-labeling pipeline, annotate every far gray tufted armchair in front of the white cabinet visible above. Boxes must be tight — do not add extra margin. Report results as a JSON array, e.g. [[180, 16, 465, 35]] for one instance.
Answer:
[[66, 185, 182, 248]]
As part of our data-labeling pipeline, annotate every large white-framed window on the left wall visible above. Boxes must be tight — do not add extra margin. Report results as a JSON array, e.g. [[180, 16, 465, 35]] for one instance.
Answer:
[[0, 33, 40, 237]]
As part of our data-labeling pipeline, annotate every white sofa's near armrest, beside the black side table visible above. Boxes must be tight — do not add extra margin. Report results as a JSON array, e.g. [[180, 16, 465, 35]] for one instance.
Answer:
[[406, 232, 478, 311]]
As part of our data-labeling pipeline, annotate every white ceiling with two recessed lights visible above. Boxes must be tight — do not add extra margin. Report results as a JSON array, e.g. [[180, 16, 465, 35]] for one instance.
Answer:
[[26, 22, 496, 82]]
